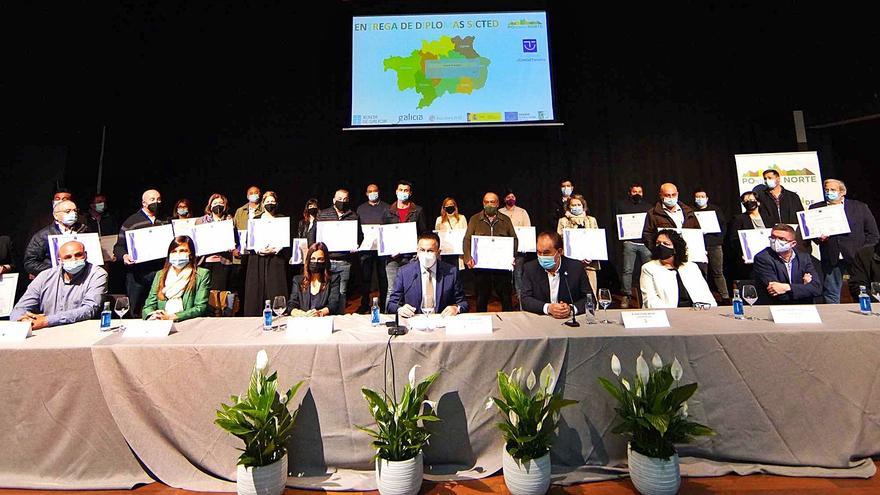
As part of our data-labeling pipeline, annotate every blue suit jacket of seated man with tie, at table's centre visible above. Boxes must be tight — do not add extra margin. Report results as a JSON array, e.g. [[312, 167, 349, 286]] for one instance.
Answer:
[[388, 259, 468, 313]]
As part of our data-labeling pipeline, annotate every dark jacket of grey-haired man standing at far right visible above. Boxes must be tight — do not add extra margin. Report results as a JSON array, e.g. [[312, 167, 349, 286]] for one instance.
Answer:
[[810, 199, 880, 271]]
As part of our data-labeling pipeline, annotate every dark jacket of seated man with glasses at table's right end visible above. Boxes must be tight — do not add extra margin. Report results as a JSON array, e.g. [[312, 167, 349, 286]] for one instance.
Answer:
[[754, 248, 822, 304]]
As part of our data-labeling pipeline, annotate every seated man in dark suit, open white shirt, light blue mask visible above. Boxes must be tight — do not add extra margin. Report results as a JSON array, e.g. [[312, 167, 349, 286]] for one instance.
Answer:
[[521, 232, 593, 319]]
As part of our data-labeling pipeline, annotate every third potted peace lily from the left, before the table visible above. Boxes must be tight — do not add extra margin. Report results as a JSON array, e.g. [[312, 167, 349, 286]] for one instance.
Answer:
[[486, 363, 577, 495]]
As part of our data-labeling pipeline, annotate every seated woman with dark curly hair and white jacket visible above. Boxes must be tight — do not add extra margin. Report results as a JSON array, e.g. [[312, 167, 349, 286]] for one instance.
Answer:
[[639, 230, 718, 309]]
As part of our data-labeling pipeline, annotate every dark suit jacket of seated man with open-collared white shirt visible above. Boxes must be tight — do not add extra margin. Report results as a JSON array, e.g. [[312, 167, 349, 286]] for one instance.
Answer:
[[520, 256, 593, 315]]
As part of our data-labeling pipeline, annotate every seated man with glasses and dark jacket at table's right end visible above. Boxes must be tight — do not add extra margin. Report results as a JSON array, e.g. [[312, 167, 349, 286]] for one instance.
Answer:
[[753, 223, 822, 304]]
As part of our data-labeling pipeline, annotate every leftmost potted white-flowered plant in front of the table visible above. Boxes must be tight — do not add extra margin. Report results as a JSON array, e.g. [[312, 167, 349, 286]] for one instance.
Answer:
[[214, 350, 303, 495]]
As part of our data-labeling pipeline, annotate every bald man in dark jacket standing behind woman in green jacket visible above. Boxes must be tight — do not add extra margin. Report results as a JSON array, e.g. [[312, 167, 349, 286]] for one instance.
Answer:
[[113, 189, 168, 318]]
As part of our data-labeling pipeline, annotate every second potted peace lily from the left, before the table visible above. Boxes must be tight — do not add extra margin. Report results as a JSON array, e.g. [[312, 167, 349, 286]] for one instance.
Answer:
[[357, 365, 440, 495]]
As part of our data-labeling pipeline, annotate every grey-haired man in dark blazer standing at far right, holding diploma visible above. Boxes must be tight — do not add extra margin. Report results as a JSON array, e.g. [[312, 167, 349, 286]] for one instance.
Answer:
[[810, 179, 880, 304]]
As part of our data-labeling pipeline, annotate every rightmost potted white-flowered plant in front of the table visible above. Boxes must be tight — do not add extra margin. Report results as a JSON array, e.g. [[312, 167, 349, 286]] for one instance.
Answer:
[[599, 353, 715, 495]]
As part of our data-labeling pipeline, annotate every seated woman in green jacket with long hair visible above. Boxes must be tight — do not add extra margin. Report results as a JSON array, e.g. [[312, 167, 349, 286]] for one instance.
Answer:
[[141, 235, 211, 321]]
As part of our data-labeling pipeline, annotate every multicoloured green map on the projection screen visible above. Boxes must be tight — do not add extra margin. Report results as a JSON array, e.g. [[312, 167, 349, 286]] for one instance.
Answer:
[[384, 36, 491, 108]]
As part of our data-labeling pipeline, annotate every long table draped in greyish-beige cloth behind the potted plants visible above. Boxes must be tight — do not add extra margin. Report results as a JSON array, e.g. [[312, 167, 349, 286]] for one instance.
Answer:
[[0, 305, 880, 491]]
